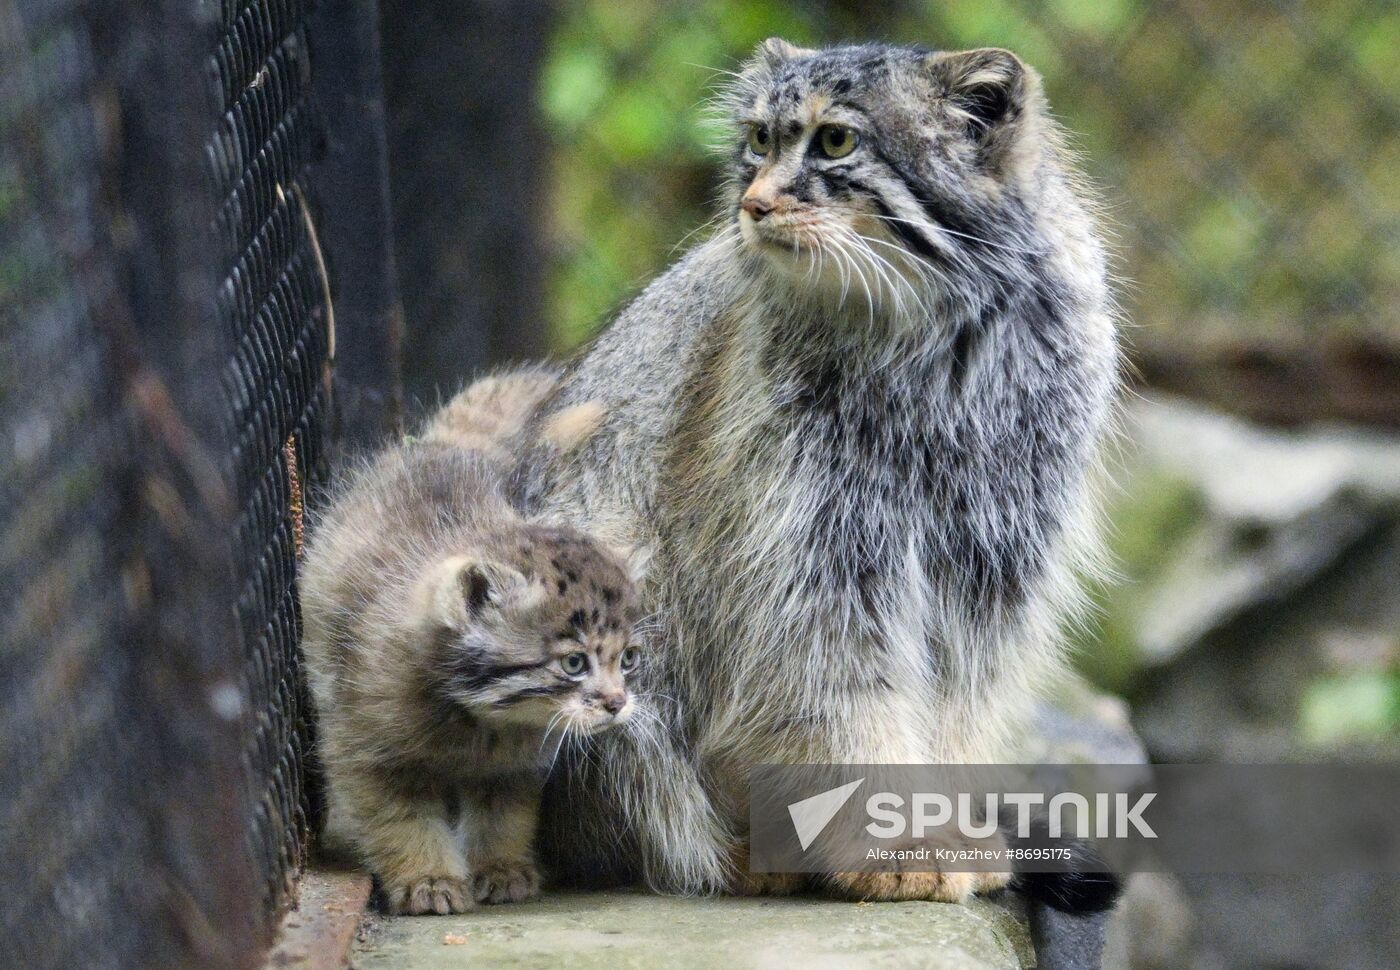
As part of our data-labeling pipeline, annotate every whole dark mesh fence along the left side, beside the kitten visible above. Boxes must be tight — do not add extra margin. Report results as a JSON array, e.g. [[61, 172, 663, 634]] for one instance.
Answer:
[[0, 0, 396, 970]]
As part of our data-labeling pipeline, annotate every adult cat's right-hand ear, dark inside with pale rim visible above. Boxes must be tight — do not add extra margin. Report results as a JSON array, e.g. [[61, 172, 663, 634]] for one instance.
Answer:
[[924, 48, 1040, 146]]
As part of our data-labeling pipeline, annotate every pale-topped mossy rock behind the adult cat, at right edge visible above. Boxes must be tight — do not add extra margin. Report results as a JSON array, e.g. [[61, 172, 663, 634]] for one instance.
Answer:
[[1089, 398, 1400, 674]]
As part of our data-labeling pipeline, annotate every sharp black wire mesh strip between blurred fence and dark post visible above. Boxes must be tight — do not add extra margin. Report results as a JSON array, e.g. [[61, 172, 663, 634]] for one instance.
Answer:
[[209, 0, 329, 910]]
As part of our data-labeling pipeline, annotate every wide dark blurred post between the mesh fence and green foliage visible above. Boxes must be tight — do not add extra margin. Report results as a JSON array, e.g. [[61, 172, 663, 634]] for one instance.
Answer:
[[382, 0, 556, 412]]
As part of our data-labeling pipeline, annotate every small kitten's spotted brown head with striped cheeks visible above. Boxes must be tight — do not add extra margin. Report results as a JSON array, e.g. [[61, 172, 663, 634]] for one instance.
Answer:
[[424, 526, 643, 733]]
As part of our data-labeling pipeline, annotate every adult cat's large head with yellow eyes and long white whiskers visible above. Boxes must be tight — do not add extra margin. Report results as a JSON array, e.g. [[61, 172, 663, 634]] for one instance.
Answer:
[[722, 39, 1049, 317]]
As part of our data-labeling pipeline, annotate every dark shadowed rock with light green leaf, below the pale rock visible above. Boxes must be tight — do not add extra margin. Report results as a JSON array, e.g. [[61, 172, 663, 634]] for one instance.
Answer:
[[1134, 522, 1400, 763]]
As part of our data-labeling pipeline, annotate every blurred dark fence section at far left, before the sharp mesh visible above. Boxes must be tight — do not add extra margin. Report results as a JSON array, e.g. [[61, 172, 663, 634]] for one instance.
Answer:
[[0, 1, 265, 967]]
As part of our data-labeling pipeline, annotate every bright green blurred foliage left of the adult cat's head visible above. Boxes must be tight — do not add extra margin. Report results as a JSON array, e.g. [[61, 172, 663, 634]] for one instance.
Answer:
[[540, 0, 815, 347]]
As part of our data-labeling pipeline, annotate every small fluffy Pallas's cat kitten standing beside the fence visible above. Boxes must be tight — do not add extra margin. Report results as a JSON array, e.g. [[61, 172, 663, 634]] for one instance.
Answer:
[[301, 441, 638, 913]]
